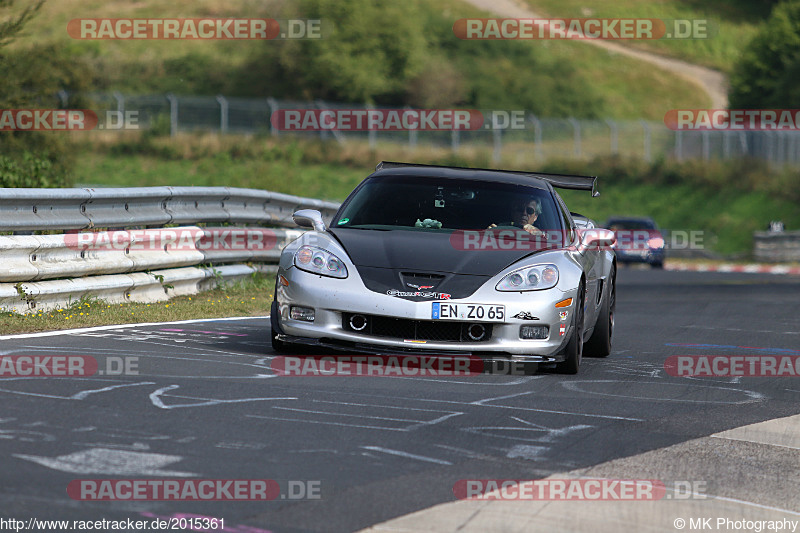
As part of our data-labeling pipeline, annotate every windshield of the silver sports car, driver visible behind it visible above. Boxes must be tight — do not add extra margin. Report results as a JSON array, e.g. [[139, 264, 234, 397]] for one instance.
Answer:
[[333, 176, 561, 236]]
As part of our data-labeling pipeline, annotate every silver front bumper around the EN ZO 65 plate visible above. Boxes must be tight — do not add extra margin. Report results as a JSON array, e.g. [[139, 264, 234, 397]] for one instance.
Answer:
[[275, 267, 577, 362]]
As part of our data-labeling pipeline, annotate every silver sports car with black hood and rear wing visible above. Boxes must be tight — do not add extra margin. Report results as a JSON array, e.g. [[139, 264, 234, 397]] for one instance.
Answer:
[[271, 162, 616, 374]]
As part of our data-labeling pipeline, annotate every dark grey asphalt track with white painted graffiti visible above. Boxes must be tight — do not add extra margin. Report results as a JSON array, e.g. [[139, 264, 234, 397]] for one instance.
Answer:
[[0, 268, 800, 533]]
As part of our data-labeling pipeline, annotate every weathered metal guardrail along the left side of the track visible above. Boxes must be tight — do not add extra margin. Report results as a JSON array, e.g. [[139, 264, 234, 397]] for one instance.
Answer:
[[0, 187, 339, 313]]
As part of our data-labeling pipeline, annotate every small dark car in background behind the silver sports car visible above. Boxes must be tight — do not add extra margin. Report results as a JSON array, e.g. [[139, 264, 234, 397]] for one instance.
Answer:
[[603, 216, 666, 268]]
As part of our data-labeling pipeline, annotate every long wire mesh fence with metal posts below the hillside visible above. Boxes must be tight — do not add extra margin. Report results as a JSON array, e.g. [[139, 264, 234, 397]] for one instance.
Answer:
[[86, 93, 800, 167]]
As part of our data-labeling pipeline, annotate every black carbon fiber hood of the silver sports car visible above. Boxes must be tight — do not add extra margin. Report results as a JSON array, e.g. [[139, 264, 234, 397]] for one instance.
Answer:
[[329, 228, 534, 301]]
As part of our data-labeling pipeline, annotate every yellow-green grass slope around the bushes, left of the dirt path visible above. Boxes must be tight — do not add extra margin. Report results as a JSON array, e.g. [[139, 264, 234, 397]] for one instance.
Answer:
[[3, 0, 709, 120]]
